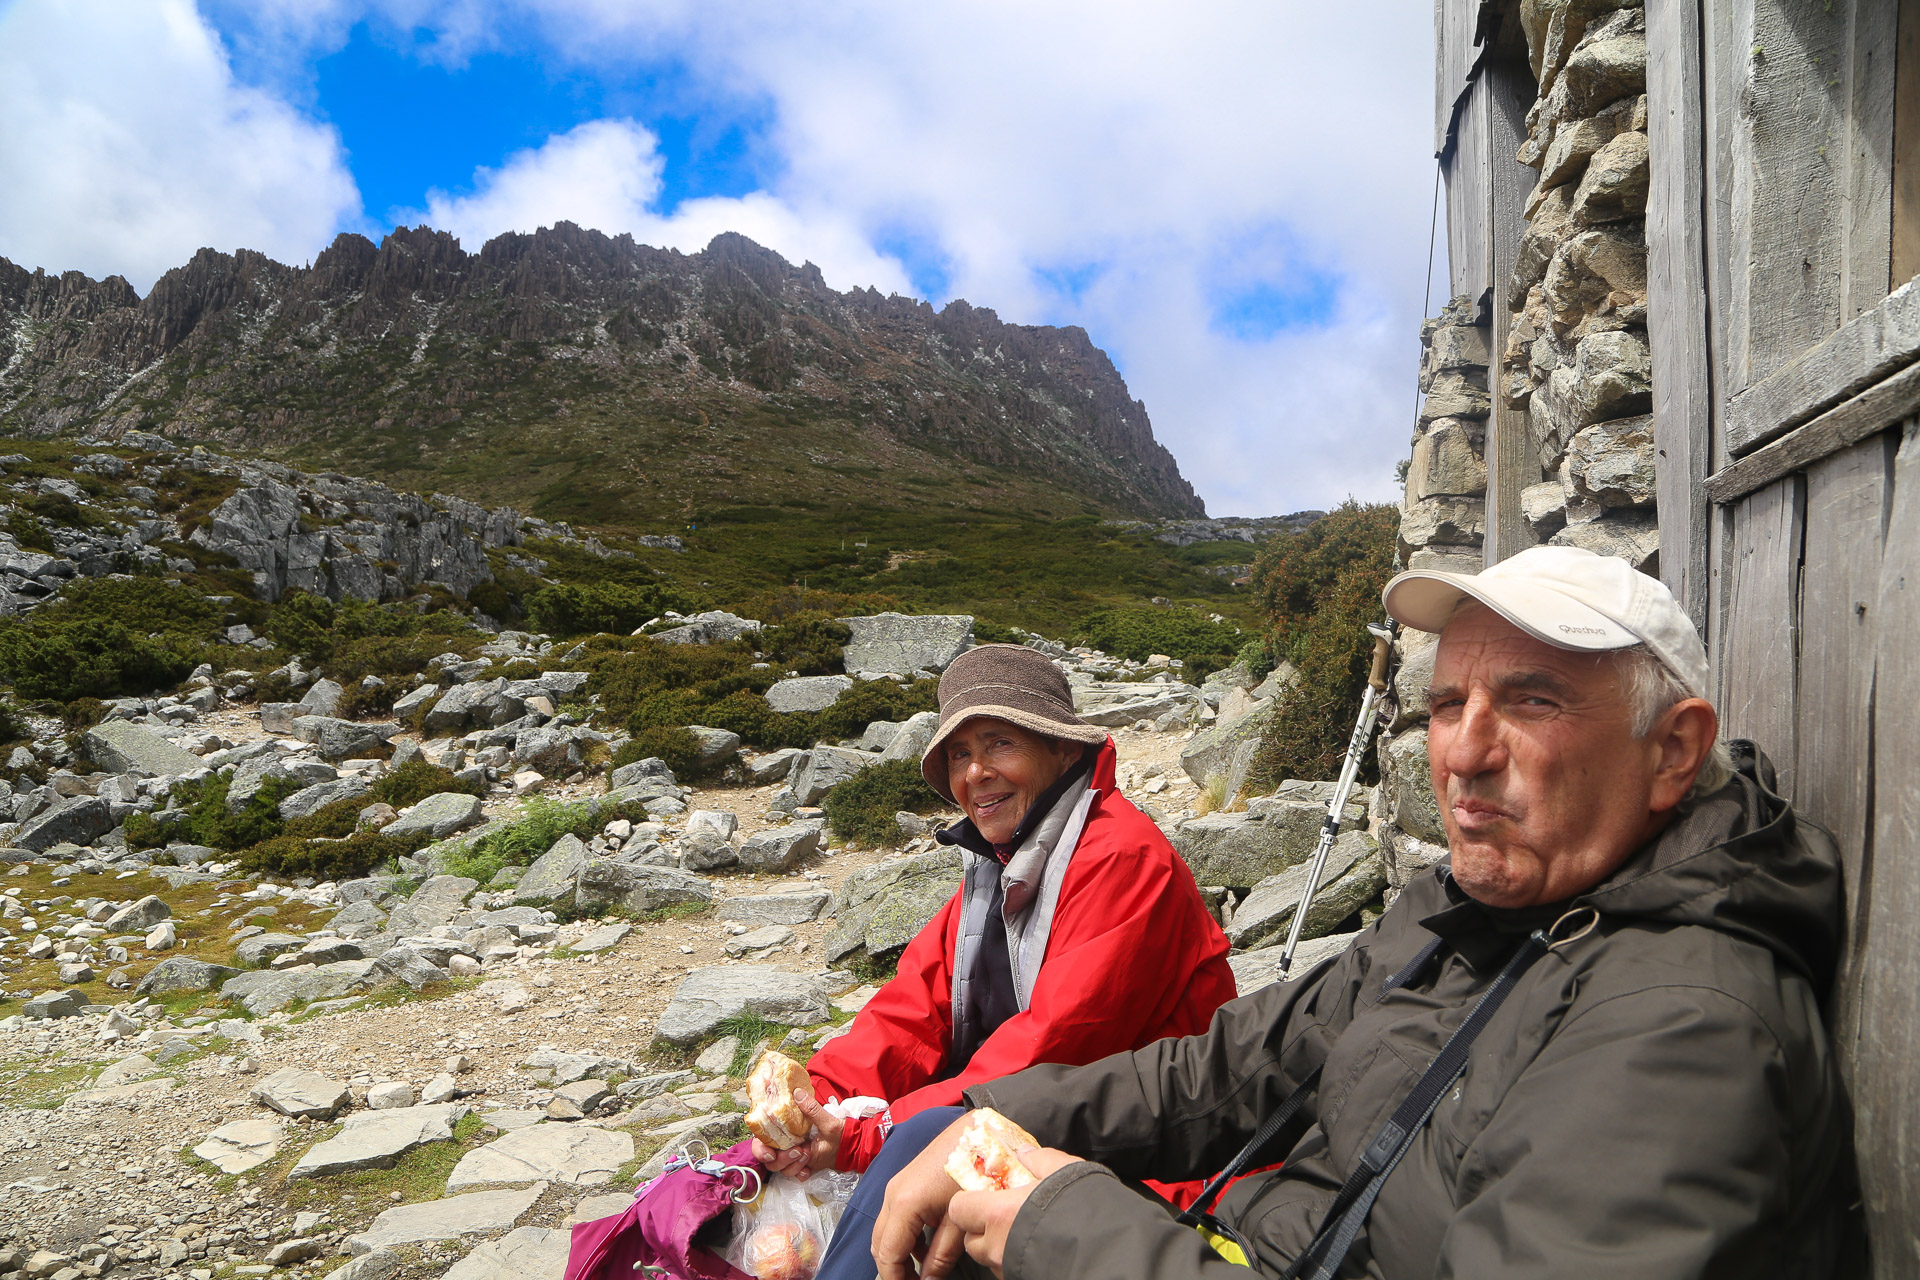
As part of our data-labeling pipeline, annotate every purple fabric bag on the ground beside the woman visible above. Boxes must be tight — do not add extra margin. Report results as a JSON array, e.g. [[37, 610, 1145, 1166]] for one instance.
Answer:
[[566, 1138, 762, 1280]]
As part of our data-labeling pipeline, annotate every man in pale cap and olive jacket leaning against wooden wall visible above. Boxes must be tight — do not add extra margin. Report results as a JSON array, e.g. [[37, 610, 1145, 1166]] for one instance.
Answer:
[[874, 547, 1857, 1280]]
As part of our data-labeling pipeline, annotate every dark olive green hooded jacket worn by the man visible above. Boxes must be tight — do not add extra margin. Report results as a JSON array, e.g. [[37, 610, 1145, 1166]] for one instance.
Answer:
[[968, 745, 1860, 1280]]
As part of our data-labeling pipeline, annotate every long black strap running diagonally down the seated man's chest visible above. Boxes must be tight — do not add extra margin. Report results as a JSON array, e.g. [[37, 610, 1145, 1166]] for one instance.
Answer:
[[1281, 931, 1549, 1280]]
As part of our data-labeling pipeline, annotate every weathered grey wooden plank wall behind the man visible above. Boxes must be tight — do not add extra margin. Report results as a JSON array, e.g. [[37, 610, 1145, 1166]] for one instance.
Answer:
[[1647, 0, 1920, 1276]]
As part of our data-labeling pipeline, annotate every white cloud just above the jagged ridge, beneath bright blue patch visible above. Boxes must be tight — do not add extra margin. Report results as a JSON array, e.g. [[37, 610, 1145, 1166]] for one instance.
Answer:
[[419, 119, 908, 292]]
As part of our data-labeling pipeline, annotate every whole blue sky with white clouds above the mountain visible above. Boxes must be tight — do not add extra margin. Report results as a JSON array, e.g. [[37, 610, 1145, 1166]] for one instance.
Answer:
[[0, 0, 1444, 514]]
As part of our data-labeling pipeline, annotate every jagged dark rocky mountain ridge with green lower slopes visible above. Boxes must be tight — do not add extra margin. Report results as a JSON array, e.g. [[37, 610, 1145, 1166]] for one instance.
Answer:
[[0, 223, 1204, 524]]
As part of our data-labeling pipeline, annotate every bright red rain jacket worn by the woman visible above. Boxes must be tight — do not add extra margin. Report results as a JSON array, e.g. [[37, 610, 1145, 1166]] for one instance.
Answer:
[[806, 739, 1235, 1171]]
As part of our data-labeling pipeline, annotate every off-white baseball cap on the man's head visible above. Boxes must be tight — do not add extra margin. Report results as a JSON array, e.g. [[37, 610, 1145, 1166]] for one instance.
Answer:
[[1380, 547, 1709, 699]]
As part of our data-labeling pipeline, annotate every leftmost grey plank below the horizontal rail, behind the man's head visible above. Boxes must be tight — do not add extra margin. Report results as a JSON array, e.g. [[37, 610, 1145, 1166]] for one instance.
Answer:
[[1720, 474, 1805, 800]]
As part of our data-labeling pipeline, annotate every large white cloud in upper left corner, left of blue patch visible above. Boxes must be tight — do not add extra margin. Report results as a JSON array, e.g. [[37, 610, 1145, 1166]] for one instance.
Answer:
[[0, 0, 359, 290]]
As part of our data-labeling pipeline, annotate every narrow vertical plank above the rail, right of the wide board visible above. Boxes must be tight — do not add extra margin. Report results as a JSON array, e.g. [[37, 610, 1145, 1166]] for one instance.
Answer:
[[1839, 0, 1899, 324]]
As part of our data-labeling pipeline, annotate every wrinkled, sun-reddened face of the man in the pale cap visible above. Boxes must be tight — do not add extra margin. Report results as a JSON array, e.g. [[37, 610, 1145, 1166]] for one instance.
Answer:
[[1428, 604, 1661, 908]]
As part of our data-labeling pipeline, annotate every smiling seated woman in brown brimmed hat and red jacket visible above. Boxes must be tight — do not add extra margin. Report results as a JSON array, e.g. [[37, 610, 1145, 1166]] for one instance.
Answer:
[[755, 645, 1235, 1280]]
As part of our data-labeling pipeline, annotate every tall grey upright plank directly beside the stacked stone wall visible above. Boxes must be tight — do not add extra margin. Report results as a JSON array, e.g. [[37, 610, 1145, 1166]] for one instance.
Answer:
[[1647, 0, 1713, 628]]
